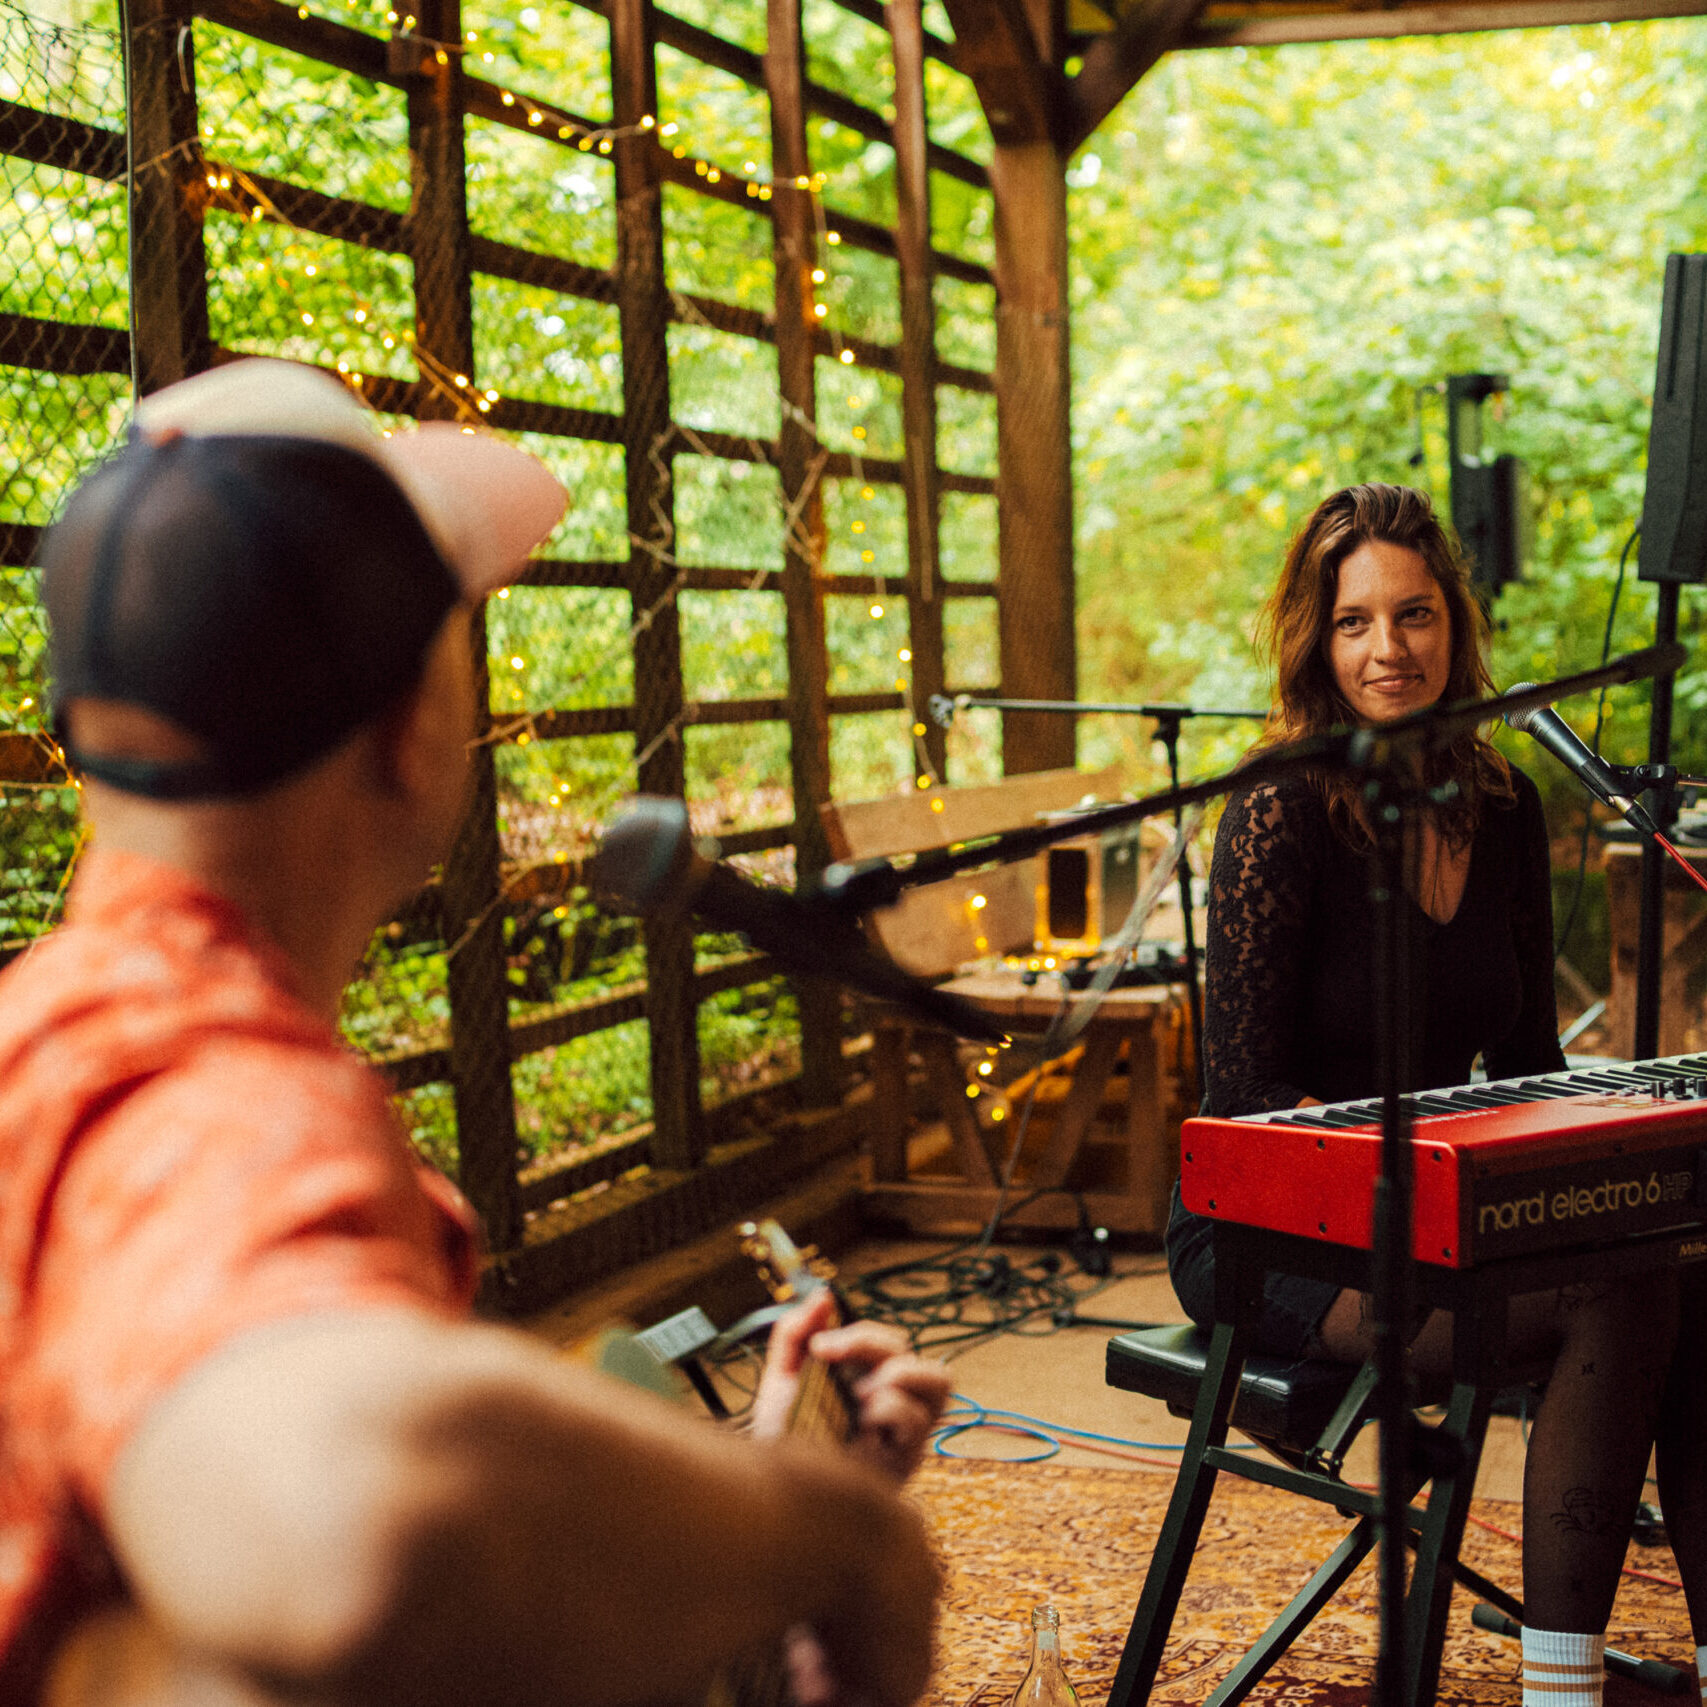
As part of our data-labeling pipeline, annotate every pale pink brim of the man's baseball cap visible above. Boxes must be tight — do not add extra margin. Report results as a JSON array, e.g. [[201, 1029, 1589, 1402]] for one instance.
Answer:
[[381, 422, 568, 599]]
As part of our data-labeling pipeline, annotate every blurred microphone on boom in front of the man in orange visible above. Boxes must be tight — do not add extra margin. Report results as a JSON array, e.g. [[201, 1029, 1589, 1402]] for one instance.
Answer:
[[587, 795, 1007, 1043]]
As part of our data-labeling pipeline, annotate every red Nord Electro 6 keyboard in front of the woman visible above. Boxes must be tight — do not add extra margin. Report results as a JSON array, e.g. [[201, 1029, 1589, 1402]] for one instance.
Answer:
[[1180, 1055, 1707, 1268]]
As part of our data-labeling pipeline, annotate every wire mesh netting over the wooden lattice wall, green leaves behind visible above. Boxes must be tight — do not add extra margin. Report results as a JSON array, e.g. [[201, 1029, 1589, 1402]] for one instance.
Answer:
[[0, 0, 995, 1215]]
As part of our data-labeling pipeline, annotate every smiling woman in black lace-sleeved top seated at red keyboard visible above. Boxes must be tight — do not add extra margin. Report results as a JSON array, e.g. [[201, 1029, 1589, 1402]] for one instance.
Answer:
[[1168, 485, 1707, 1707]]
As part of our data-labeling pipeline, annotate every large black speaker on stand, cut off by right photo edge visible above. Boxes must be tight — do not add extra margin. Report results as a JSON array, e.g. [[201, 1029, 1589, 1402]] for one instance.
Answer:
[[1637, 254, 1707, 582]]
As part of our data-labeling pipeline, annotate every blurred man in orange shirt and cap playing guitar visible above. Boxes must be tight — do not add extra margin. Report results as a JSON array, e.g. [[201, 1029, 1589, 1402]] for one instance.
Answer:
[[0, 360, 946, 1707]]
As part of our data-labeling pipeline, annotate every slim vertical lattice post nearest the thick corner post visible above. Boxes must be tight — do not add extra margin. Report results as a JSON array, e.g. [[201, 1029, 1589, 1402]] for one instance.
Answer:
[[884, 0, 947, 780]]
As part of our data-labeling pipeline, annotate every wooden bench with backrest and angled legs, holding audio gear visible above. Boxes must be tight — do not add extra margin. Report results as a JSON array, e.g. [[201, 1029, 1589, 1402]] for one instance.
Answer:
[[823, 770, 1195, 1234]]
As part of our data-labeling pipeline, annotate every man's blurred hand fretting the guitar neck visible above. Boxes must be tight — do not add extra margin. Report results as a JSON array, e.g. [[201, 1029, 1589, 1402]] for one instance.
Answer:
[[753, 1289, 951, 1482]]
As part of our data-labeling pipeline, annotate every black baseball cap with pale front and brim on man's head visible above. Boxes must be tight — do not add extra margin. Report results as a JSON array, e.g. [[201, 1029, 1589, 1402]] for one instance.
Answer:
[[41, 358, 567, 801]]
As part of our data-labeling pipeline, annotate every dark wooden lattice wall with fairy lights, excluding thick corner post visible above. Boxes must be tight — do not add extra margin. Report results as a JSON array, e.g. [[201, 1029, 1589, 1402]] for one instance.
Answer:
[[0, 0, 1024, 1299]]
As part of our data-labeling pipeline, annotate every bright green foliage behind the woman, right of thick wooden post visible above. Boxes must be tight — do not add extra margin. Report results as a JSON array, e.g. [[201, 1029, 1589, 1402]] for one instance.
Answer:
[[1072, 19, 1707, 787]]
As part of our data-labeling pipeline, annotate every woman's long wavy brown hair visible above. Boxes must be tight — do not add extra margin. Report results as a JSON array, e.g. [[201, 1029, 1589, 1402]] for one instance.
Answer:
[[1258, 481, 1514, 847]]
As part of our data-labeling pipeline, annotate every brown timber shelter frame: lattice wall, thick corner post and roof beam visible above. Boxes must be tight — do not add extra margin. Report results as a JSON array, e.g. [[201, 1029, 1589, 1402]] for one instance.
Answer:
[[0, 0, 1702, 1297]]
